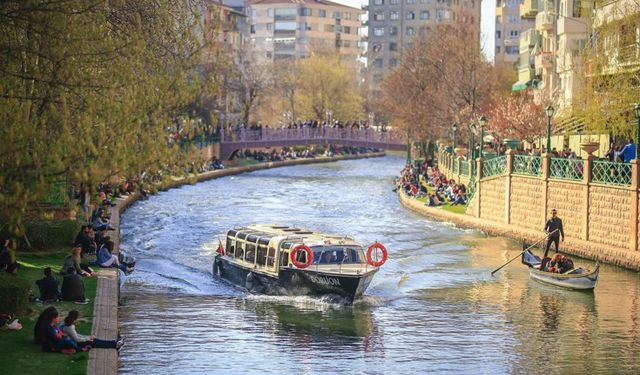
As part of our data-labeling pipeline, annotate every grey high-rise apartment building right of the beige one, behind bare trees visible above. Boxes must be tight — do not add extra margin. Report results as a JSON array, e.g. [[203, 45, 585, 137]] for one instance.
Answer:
[[365, 0, 482, 88]]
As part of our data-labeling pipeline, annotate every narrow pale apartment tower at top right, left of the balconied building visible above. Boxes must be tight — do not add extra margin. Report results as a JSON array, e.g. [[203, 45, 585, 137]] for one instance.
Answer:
[[494, 0, 535, 64]]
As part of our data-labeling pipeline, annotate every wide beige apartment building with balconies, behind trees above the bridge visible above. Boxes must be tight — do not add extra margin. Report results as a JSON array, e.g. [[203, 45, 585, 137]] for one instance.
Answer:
[[248, 0, 362, 64]]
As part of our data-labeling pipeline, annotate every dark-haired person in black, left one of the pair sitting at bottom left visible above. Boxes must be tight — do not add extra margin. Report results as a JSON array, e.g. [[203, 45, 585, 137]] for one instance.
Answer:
[[34, 306, 85, 354]]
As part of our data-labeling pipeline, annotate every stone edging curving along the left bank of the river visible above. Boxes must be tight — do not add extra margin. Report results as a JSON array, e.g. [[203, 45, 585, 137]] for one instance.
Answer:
[[87, 152, 385, 375]]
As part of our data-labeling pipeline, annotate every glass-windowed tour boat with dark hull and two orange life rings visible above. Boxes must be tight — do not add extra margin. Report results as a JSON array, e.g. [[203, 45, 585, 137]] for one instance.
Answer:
[[213, 224, 388, 301]]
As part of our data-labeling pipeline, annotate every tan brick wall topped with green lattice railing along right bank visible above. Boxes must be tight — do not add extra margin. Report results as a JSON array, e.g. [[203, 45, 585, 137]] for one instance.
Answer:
[[438, 150, 640, 268]]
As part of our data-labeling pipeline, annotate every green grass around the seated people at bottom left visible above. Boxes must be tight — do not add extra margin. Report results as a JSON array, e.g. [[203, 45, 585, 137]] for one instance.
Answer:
[[0, 249, 97, 375]]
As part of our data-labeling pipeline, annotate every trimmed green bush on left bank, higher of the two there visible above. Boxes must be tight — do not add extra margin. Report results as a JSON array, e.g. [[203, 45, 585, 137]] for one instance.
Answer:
[[25, 220, 82, 248]]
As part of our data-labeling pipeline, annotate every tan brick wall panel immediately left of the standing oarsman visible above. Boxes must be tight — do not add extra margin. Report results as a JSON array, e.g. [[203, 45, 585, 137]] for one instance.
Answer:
[[509, 176, 544, 230]]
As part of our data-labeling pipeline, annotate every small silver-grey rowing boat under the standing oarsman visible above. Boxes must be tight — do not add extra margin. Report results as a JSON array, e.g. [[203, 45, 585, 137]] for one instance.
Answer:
[[522, 250, 600, 290]]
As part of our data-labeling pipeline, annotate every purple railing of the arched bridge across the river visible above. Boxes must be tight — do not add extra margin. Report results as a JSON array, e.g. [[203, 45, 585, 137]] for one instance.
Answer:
[[222, 128, 406, 144]]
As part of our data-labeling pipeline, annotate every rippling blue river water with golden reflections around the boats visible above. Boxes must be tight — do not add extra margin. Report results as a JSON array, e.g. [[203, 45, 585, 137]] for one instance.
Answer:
[[120, 157, 640, 374]]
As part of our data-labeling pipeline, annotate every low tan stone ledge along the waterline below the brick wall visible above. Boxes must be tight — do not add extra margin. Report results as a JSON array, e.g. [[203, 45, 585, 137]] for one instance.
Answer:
[[398, 189, 640, 271]]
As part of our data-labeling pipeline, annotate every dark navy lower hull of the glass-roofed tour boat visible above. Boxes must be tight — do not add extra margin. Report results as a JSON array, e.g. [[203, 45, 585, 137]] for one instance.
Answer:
[[213, 255, 378, 300]]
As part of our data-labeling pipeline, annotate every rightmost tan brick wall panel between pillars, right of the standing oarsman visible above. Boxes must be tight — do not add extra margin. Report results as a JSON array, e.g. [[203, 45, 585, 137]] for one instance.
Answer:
[[589, 186, 631, 249]]
